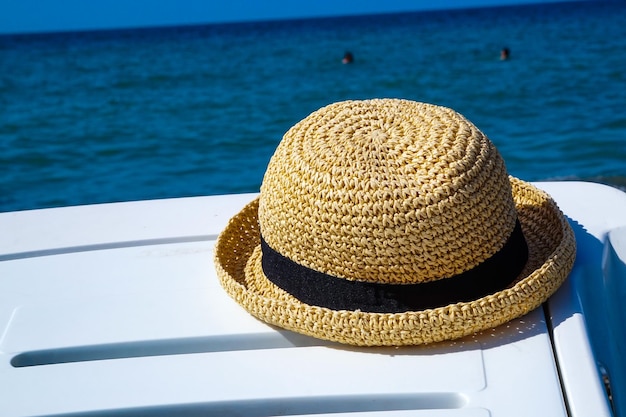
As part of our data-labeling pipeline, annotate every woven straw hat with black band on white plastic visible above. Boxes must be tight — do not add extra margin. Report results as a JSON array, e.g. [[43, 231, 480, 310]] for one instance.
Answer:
[[215, 99, 576, 346]]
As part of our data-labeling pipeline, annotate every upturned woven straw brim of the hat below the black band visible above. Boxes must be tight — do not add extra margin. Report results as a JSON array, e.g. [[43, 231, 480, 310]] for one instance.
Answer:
[[215, 177, 576, 346]]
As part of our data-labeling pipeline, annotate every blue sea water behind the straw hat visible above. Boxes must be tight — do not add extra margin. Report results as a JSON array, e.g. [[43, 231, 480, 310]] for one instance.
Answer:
[[0, 1, 626, 211]]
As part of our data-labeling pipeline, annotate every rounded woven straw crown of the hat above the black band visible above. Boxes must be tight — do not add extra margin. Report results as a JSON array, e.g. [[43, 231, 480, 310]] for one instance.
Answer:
[[259, 99, 517, 284]]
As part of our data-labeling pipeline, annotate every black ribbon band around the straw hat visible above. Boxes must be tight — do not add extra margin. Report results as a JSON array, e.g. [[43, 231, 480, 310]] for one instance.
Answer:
[[261, 220, 528, 313]]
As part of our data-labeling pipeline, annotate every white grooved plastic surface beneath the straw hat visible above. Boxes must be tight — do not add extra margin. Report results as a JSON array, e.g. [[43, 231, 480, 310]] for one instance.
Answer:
[[0, 183, 621, 417]]
